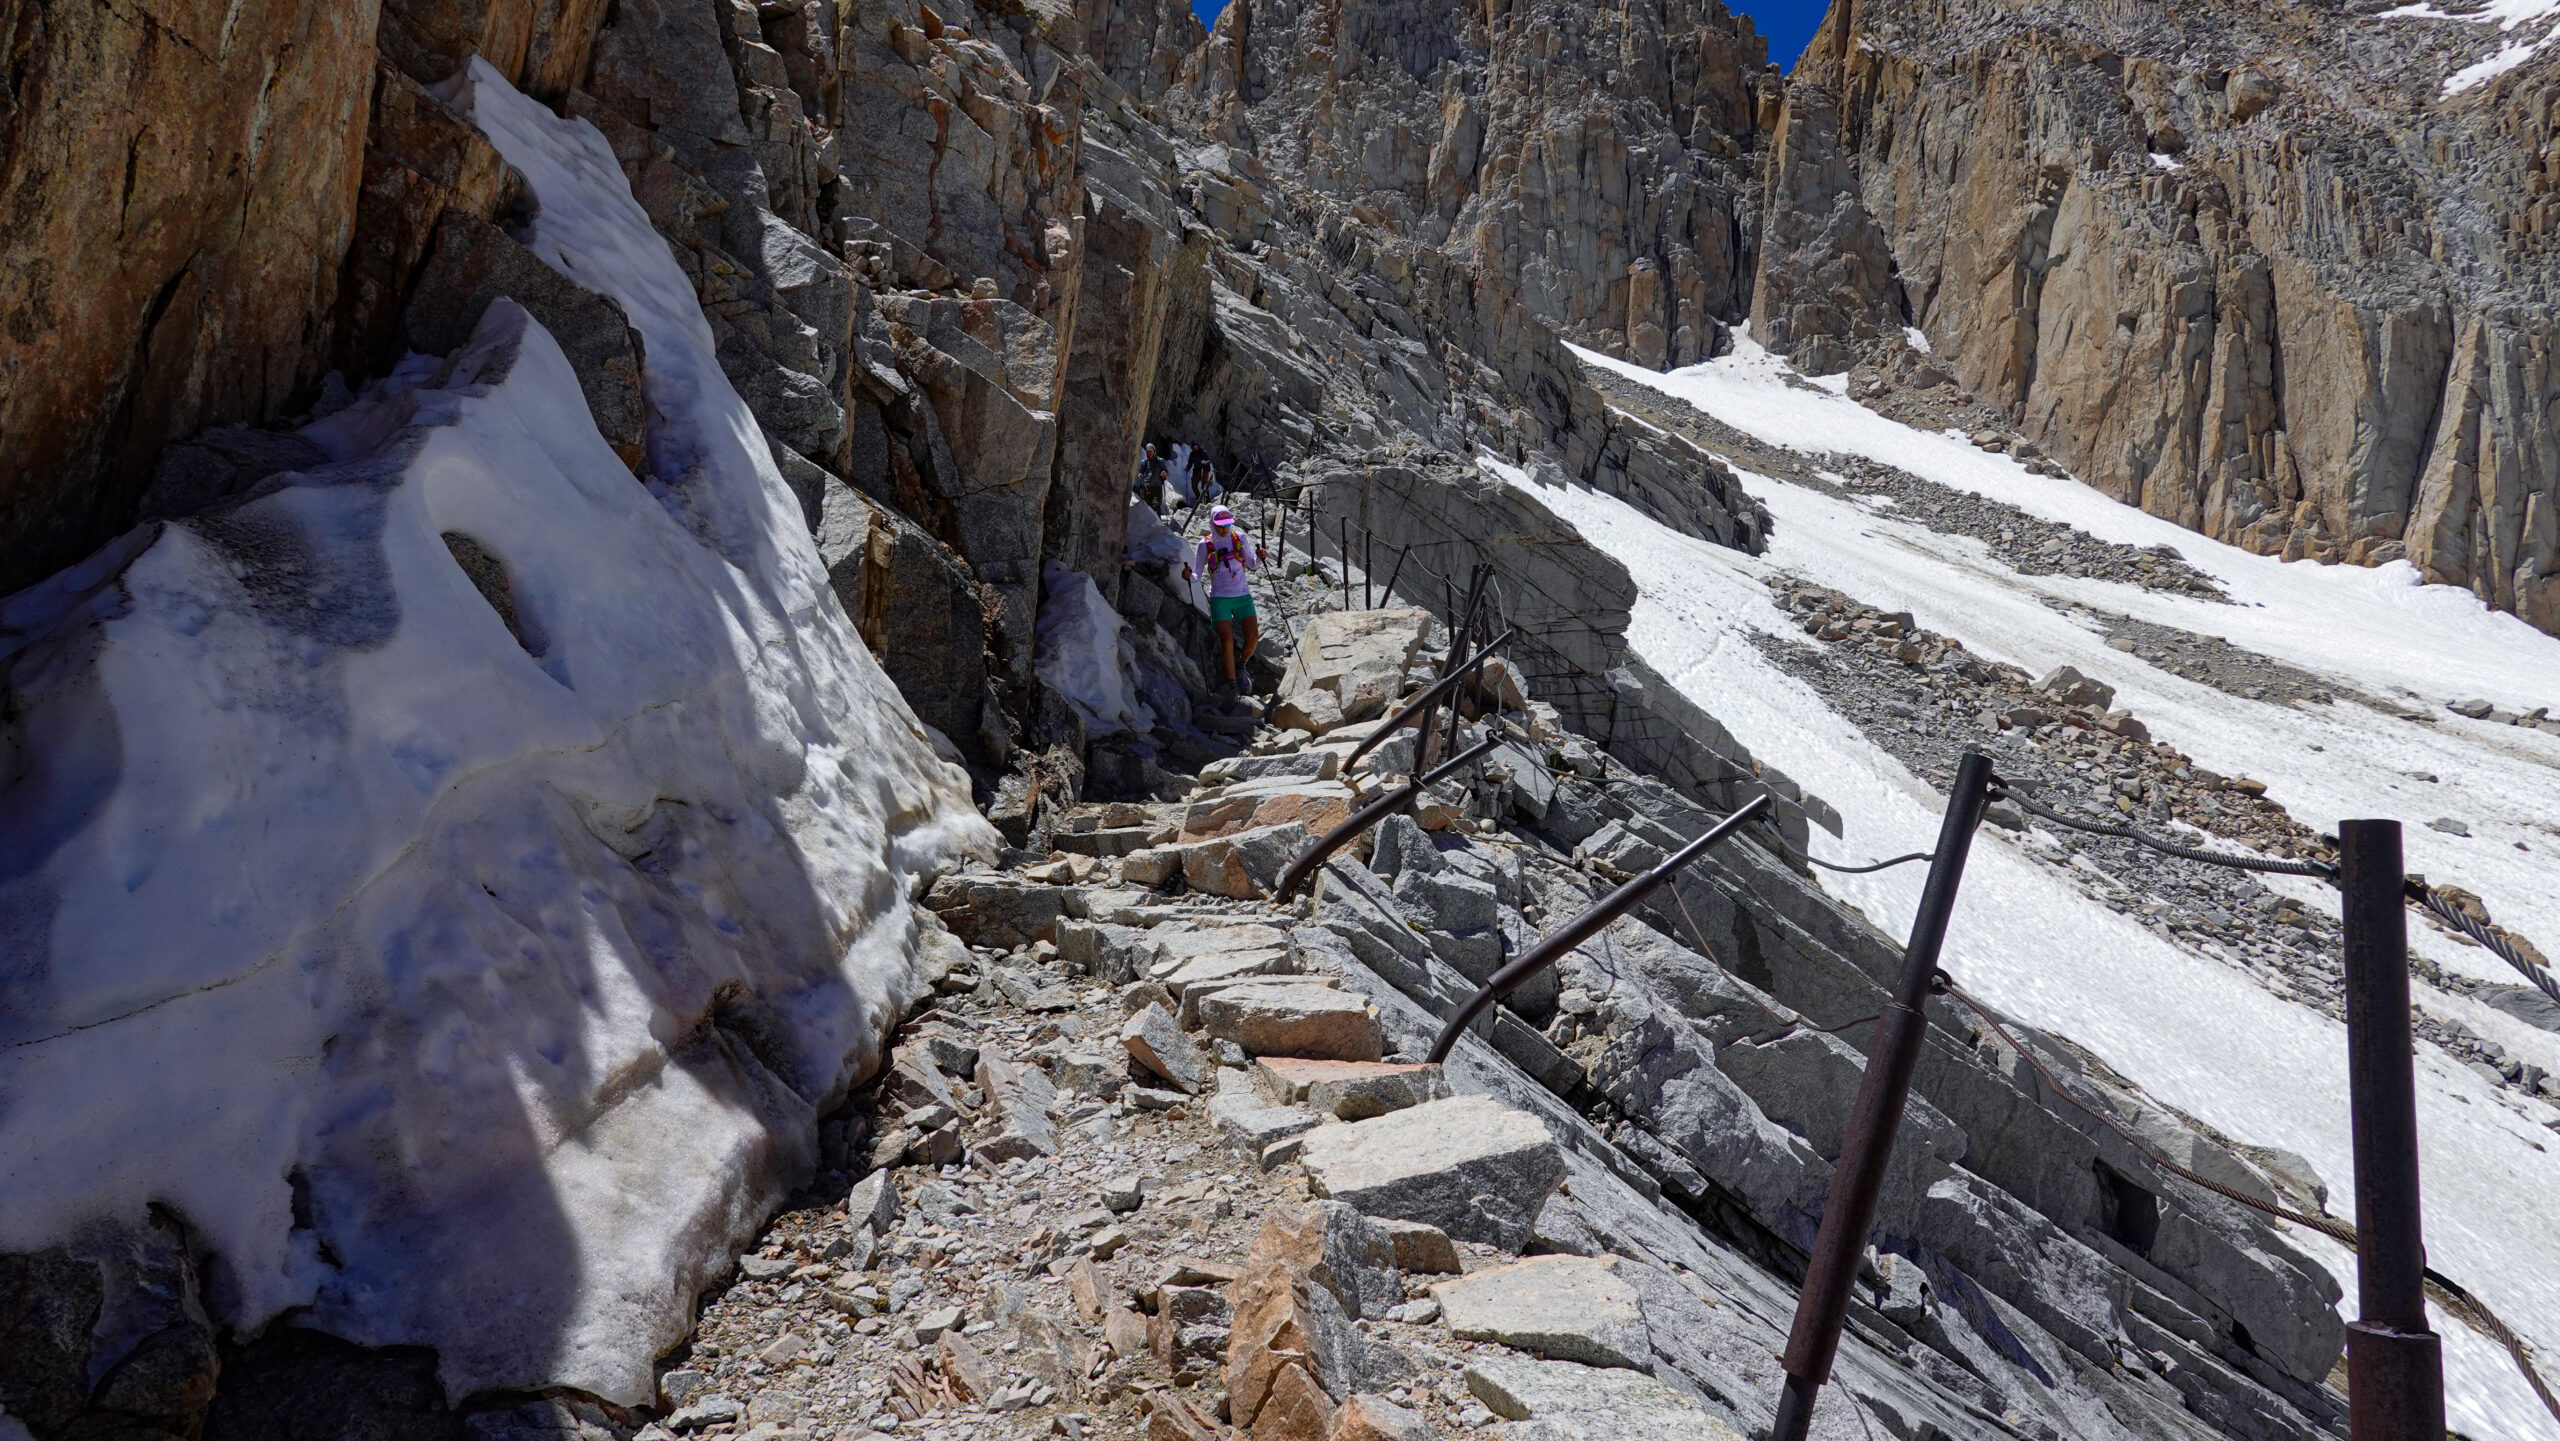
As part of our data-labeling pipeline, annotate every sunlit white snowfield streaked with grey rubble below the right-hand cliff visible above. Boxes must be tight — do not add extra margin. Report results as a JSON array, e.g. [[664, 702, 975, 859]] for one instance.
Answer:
[[1556, 340, 2560, 1441]]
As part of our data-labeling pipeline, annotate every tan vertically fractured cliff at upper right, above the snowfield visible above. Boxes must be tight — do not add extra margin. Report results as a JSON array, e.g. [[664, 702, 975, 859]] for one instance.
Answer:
[[1754, 0, 2560, 630]]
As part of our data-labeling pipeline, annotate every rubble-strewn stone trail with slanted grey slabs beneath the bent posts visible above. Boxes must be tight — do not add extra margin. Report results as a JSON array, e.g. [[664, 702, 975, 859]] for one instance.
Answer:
[[634, 573, 2396, 1441]]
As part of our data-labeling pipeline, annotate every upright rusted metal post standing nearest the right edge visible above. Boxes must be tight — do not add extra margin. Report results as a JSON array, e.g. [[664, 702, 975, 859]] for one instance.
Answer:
[[2337, 822, 2445, 1441]]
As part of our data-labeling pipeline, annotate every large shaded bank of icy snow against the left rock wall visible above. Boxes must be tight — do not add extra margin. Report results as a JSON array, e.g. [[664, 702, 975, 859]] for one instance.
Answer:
[[0, 61, 993, 1403]]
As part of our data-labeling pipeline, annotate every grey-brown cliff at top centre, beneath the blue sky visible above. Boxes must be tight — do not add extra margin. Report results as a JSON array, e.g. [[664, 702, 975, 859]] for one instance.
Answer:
[[1172, 0, 1779, 366]]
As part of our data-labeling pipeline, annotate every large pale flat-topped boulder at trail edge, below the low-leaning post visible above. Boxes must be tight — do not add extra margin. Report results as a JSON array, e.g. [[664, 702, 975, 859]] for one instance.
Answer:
[[1298, 1095, 1564, 1252]]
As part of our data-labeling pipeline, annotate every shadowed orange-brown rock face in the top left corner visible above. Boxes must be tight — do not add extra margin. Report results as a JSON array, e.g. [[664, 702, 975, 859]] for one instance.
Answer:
[[0, 0, 374, 591]]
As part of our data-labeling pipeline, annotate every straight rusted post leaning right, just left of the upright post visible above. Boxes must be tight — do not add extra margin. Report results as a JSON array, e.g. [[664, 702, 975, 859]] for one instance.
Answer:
[[1769, 750, 1992, 1441]]
